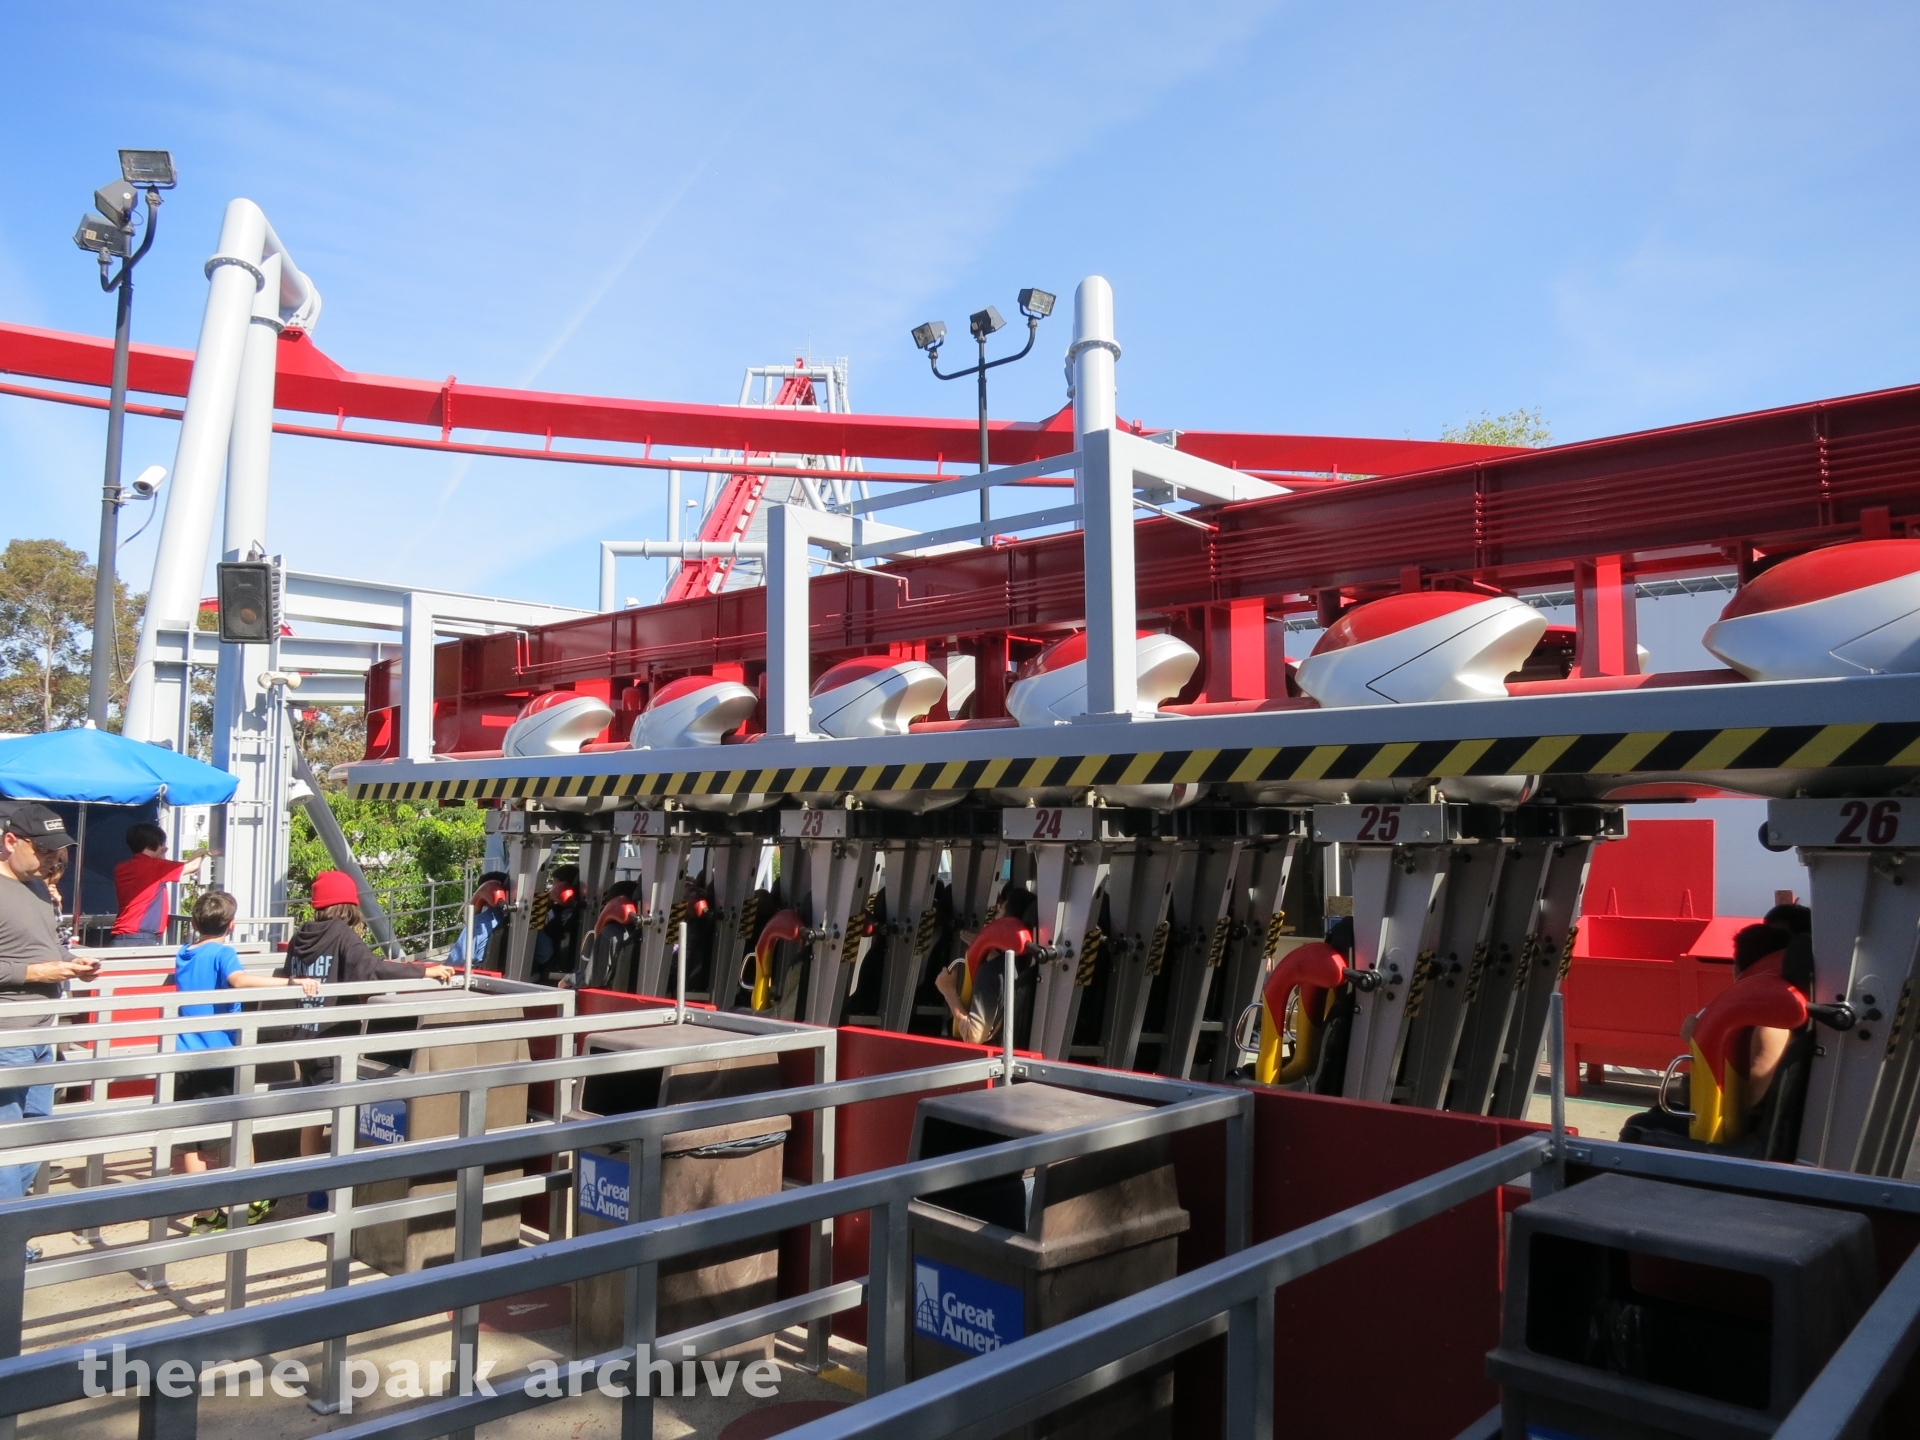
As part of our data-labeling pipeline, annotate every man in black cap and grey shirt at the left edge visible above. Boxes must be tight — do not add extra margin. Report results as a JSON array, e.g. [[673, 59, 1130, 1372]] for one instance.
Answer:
[[0, 801, 98, 1200]]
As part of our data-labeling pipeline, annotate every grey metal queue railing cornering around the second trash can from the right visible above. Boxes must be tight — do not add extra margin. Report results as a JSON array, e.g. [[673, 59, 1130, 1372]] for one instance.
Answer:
[[0, 1050, 1252, 1440]]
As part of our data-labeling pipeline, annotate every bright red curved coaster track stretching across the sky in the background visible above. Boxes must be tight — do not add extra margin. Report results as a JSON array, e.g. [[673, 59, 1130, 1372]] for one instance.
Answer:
[[0, 323, 1507, 474]]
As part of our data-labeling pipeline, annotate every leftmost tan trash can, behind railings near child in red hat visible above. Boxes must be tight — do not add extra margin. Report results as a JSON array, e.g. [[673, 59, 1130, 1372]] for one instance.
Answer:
[[353, 1010, 528, 1275]]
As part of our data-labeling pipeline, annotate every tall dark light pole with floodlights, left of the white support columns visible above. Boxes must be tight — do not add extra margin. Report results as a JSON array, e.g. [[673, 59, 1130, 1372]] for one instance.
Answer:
[[73, 150, 175, 730]]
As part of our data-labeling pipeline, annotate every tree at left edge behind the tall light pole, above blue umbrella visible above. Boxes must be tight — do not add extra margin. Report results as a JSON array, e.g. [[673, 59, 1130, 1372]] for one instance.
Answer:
[[0, 540, 144, 732]]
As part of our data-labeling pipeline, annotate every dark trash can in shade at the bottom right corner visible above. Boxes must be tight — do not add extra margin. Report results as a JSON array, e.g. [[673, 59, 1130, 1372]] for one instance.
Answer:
[[1488, 1175, 1880, 1440]]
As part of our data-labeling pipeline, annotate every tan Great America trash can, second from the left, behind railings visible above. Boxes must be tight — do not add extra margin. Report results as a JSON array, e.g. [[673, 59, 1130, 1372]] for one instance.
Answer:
[[568, 1025, 793, 1359]]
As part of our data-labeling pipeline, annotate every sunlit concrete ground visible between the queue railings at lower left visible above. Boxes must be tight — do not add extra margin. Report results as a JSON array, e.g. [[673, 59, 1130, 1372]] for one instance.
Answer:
[[19, 1158, 866, 1440]]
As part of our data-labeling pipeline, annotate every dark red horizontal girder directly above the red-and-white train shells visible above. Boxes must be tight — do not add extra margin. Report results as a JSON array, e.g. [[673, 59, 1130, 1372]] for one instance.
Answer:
[[385, 372, 1920, 753]]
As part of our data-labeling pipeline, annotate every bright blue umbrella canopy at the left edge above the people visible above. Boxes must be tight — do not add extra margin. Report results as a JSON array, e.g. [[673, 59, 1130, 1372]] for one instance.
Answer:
[[0, 730, 240, 804]]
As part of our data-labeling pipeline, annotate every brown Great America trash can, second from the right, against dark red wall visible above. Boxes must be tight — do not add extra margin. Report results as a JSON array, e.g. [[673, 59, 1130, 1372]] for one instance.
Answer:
[[906, 1085, 1188, 1440]]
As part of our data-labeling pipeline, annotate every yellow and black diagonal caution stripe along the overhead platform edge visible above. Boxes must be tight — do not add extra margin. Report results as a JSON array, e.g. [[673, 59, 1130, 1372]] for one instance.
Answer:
[[353, 722, 1920, 801]]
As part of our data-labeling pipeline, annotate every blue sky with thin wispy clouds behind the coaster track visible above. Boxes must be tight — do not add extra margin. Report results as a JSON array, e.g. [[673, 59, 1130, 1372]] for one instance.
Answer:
[[0, 0, 1920, 913]]
